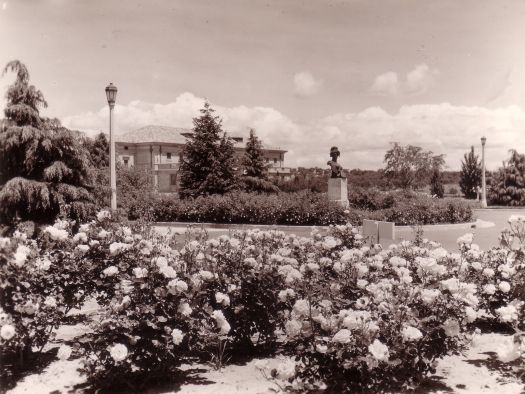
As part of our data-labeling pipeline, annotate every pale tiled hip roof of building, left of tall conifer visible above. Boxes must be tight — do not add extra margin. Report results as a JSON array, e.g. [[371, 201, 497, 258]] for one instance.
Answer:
[[115, 126, 192, 144]]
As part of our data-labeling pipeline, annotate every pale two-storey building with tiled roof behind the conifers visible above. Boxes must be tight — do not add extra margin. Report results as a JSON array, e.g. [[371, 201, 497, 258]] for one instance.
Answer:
[[115, 126, 291, 193]]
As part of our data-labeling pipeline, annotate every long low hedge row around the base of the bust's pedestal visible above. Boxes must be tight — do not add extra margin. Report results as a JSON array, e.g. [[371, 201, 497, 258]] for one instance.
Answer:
[[128, 192, 472, 226]]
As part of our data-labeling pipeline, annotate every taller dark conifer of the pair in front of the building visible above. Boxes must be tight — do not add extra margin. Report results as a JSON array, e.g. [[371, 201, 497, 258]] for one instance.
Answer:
[[179, 102, 236, 198]]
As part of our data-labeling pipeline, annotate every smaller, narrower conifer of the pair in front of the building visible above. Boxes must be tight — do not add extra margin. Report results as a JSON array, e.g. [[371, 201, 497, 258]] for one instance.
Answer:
[[240, 129, 279, 192]]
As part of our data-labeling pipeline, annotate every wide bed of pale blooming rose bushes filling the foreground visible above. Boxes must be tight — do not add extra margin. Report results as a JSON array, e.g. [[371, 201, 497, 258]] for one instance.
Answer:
[[0, 212, 525, 392]]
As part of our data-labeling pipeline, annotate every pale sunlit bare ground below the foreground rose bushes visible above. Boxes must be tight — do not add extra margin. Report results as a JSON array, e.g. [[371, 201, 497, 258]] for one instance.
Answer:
[[7, 326, 525, 394]]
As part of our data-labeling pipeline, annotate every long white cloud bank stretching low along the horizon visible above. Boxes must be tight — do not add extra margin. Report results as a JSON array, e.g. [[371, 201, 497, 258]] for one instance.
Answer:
[[62, 93, 525, 170]]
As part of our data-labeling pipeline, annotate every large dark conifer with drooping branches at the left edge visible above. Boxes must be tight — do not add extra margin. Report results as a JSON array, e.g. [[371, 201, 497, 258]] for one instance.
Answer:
[[0, 60, 94, 224]]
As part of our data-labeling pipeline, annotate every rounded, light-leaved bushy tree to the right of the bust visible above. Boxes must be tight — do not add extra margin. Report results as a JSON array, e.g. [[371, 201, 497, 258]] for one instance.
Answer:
[[383, 142, 445, 189]]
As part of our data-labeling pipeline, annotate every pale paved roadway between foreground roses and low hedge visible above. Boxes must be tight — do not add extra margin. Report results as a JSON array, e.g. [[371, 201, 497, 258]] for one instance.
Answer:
[[155, 208, 525, 251]]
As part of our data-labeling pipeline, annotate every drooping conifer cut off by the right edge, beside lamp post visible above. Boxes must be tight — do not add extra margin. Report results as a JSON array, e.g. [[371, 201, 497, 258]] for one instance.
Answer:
[[488, 149, 525, 206]]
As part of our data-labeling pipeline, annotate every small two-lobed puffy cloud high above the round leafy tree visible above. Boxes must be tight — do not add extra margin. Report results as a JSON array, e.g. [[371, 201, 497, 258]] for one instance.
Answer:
[[370, 63, 439, 96]]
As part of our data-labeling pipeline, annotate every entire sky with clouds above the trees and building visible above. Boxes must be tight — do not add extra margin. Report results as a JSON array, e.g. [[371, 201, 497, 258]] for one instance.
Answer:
[[0, 0, 525, 170]]
